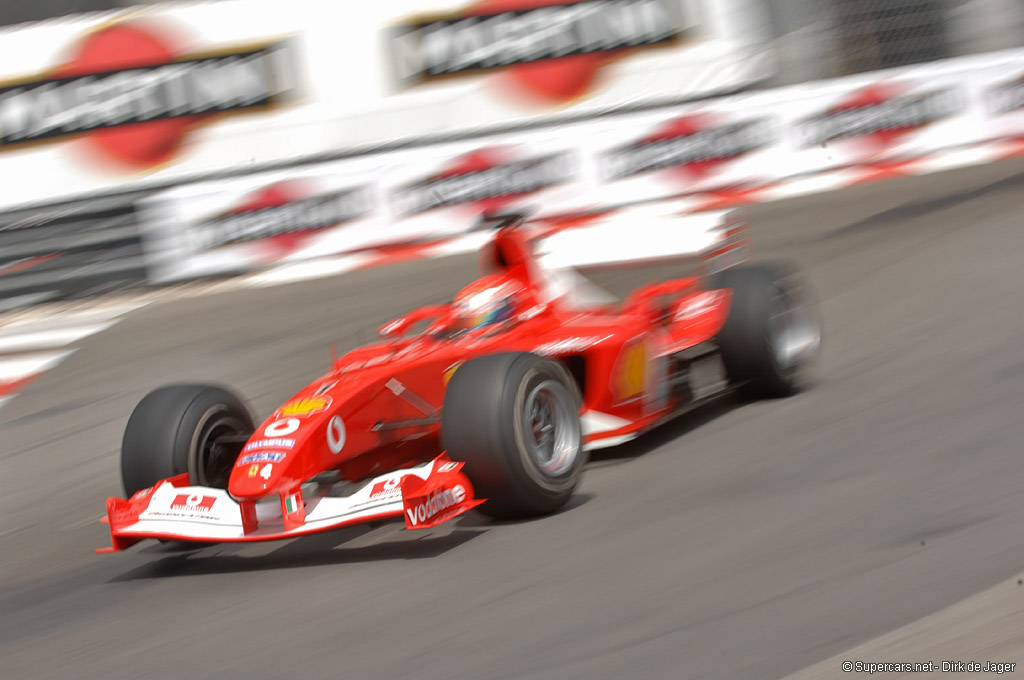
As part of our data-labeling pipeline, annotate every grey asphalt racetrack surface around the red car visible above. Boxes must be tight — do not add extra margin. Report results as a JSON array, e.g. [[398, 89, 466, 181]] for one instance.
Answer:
[[0, 156, 1024, 680]]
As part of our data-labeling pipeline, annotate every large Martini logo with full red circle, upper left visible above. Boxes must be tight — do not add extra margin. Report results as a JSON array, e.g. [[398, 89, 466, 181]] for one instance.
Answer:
[[0, 17, 293, 170]]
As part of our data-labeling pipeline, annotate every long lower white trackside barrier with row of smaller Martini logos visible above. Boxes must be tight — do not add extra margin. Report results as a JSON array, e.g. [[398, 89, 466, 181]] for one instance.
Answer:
[[144, 50, 1024, 281]]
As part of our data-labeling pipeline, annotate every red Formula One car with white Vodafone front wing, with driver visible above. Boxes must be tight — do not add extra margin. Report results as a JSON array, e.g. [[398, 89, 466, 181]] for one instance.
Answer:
[[102, 205, 820, 552]]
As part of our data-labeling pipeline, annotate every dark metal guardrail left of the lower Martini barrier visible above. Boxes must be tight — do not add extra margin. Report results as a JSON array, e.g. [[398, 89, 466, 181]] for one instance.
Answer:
[[0, 189, 145, 311]]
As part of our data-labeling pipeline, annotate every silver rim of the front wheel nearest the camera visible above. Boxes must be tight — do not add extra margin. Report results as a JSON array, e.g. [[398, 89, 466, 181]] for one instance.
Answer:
[[522, 380, 580, 476]]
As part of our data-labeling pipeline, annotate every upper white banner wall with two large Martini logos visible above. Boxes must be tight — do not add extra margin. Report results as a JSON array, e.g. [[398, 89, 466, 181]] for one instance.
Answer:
[[0, 0, 772, 209]]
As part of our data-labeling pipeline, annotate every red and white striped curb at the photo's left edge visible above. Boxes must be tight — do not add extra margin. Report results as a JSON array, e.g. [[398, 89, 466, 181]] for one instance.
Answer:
[[0, 301, 146, 407]]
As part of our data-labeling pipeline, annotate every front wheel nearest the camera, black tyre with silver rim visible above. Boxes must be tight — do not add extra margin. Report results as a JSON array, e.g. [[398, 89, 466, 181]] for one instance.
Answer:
[[441, 352, 586, 519]]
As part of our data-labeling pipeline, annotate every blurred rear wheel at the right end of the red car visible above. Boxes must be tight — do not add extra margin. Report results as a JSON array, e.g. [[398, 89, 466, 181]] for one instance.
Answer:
[[711, 263, 821, 397]]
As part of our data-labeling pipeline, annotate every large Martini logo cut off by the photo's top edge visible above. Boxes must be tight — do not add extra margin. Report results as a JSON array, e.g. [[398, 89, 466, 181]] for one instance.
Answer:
[[388, 0, 699, 104]]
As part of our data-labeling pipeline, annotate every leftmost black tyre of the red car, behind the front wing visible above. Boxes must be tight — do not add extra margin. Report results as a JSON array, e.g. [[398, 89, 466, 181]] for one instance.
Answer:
[[121, 385, 255, 498]]
